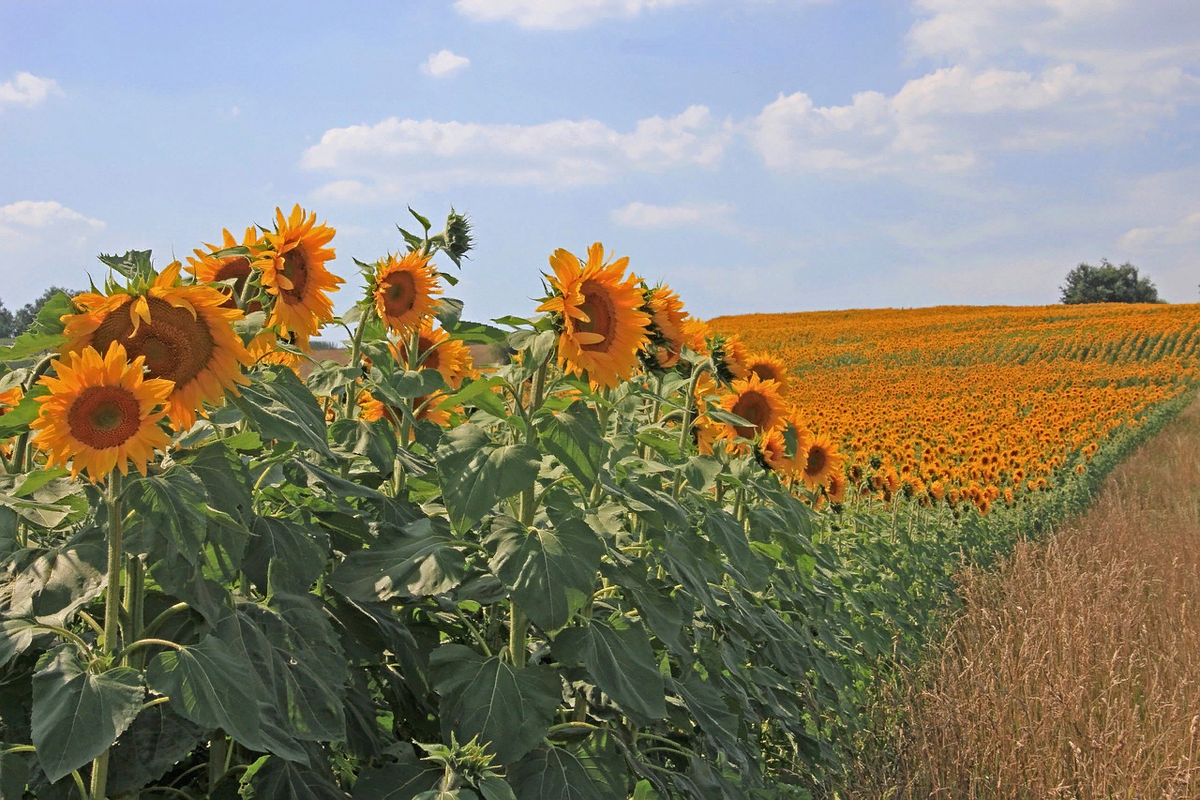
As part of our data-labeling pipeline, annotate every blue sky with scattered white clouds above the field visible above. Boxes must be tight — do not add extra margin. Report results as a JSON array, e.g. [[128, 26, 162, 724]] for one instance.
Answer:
[[0, 0, 1200, 328]]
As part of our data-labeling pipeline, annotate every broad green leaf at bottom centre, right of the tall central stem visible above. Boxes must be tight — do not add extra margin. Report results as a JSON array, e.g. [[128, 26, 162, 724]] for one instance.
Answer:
[[551, 620, 666, 724]]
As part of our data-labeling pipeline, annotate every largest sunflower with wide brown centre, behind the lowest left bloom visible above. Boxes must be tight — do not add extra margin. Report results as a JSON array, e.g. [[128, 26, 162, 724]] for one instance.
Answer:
[[62, 261, 251, 429]]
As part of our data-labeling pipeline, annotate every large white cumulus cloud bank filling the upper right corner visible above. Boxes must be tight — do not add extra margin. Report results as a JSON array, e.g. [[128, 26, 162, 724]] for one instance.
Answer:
[[746, 0, 1200, 173]]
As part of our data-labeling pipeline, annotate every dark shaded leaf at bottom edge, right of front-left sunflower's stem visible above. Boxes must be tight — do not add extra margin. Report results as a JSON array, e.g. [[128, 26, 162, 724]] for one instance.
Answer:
[[108, 705, 204, 795]]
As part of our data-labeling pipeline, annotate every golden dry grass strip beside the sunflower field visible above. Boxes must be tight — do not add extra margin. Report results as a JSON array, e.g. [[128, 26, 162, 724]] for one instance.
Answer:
[[851, 402, 1200, 799]]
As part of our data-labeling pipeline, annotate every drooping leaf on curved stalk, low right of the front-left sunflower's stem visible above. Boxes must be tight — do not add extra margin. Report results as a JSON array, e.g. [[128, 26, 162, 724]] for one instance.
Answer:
[[145, 636, 266, 751]]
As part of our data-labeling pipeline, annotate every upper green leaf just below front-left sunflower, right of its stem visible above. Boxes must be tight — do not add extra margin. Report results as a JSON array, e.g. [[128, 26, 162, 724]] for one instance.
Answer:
[[124, 465, 209, 564]]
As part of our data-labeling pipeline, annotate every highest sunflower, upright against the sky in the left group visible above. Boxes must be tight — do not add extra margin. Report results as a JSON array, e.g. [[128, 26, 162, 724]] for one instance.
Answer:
[[254, 205, 344, 337]]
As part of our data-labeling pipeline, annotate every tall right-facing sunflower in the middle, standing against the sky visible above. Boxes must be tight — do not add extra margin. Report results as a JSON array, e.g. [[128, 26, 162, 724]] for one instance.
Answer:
[[538, 242, 650, 389]]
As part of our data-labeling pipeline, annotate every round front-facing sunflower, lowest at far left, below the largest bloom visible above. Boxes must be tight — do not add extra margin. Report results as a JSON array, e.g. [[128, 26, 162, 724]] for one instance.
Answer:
[[30, 342, 174, 483]]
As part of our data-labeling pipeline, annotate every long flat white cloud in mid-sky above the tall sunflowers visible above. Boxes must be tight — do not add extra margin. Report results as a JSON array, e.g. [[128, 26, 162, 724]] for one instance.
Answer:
[[300, 106, 733, 201]]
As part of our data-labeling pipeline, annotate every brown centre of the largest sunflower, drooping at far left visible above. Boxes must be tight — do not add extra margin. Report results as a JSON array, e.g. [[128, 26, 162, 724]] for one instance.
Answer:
[[91, 297, 216, 389]]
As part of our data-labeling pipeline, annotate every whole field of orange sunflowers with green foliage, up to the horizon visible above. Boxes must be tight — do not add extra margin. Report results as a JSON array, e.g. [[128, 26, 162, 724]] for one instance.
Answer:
[[0, 206, 1196, 800]]
